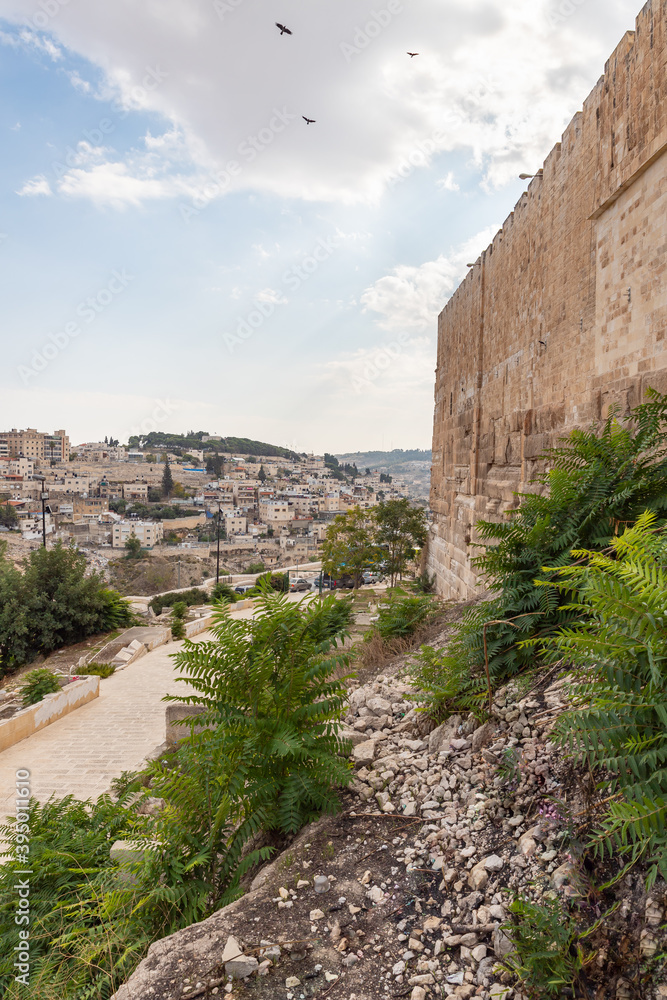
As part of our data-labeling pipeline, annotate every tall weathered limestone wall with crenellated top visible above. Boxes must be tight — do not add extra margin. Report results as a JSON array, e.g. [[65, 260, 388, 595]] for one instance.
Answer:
[[428, 0, 667, 598]]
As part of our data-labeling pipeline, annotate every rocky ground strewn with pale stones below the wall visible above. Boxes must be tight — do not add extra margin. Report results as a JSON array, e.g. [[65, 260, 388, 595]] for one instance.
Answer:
[[115, 636, 667, 1000]]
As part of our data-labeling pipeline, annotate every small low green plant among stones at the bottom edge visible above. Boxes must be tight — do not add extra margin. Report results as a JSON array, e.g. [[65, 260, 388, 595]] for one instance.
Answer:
[[502, 897, 584, 1000]]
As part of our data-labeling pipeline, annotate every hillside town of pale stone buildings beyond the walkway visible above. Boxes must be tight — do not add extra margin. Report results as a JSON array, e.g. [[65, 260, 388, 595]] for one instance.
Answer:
[[0, 428, 426, 582]]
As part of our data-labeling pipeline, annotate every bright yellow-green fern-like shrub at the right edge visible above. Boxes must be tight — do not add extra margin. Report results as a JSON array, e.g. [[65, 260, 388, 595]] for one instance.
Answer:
[[550, 512, 667, 881]]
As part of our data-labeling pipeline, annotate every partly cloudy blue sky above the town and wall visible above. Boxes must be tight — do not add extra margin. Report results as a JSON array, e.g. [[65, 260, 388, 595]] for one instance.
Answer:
[[0, 0, 640, 454]]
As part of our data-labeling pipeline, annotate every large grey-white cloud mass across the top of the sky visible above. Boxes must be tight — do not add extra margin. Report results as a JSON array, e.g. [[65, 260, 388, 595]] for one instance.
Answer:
[[4, 0, 631, 203]]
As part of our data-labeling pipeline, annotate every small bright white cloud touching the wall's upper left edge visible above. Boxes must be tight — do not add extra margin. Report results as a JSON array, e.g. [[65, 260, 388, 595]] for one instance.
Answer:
[[361, 226, 499, 331]]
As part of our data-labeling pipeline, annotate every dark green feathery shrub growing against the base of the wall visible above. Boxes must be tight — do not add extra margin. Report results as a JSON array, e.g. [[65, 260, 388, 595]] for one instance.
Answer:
[[416, 390, 667, 715]]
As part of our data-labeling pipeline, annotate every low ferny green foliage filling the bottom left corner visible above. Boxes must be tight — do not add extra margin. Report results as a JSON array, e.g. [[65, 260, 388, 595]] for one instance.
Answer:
[[0, 776, 269, 1000]]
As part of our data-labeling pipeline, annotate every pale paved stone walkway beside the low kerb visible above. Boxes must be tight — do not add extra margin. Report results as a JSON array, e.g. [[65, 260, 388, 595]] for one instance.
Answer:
[[0, 632, 210, 822]]
